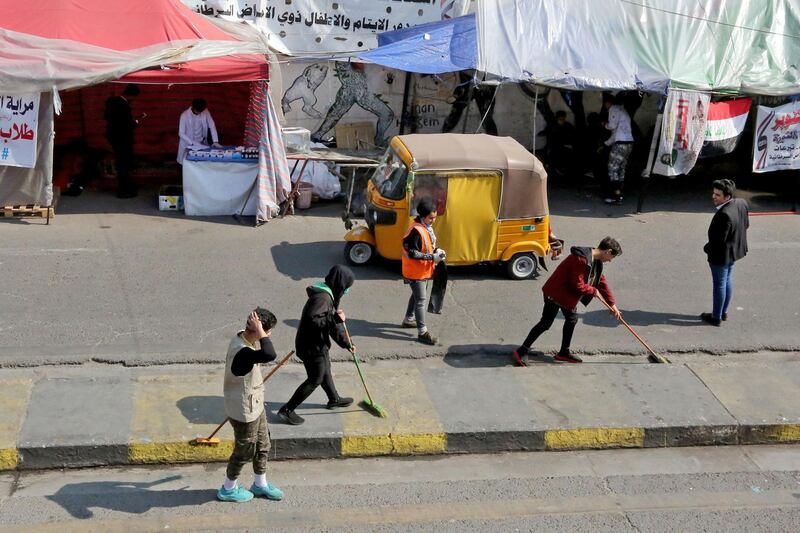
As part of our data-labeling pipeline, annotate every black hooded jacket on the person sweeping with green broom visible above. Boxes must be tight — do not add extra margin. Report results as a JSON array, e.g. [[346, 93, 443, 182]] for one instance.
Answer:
[[294, 265, 355, 361]]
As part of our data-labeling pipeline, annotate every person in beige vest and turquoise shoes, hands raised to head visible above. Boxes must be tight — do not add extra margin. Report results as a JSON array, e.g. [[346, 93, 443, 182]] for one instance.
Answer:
[[217, 307, 283, 502]]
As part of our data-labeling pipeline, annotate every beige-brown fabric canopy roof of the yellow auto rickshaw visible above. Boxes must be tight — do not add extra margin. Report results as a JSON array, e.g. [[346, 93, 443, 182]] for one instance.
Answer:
[[392, 133, 548, 219]]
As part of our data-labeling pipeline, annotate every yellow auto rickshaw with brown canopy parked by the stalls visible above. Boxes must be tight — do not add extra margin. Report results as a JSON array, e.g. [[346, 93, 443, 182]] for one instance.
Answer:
[[344, 133, 561, 279]]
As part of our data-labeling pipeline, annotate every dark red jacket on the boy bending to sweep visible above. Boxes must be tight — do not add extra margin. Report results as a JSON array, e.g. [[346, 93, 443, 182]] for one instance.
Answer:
[[542, 246, 616, 309]]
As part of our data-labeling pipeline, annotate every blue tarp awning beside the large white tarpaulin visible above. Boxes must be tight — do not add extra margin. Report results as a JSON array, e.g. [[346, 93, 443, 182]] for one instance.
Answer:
[[357, 15, 478, 74]]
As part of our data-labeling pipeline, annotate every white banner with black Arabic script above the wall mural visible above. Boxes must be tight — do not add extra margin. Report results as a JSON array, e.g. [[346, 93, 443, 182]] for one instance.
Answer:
[[181, 0, 442, 54]]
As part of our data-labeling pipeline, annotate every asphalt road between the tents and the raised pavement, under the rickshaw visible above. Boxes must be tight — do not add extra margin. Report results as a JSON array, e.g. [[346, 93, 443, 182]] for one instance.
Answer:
[[0, 180, 800, 366]]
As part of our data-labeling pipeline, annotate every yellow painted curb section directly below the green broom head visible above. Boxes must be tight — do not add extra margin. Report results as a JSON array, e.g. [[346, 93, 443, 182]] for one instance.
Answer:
[[341, 433, 447, 457]]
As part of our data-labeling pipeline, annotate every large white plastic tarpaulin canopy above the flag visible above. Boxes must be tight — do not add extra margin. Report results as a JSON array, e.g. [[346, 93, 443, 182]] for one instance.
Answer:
[[477, 0, 800, 95]]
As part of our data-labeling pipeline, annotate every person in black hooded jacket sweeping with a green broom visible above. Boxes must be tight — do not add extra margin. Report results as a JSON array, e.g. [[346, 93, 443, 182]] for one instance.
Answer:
[[278, 265, 355, 426]]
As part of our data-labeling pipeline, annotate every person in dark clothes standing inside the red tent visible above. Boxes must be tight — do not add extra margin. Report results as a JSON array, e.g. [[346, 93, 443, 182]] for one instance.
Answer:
[[104, 84, 146, 198]]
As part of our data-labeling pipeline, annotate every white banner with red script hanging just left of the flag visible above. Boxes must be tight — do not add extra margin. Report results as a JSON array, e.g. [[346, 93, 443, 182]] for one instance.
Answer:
[[653, 90, 711, 176]]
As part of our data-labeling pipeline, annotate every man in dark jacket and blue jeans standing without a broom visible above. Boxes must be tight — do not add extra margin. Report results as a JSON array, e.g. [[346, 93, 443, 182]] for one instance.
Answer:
[[700, 179, 750, 326]]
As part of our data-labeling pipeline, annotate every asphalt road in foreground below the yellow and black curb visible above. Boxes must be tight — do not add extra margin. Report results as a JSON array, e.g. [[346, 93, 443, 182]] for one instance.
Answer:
[[0, 446, 800, 533]]
